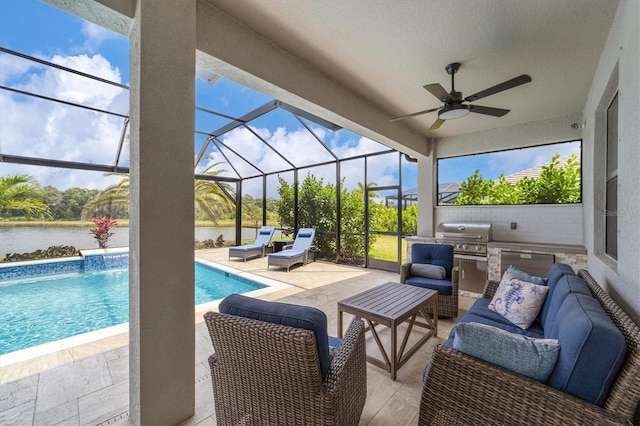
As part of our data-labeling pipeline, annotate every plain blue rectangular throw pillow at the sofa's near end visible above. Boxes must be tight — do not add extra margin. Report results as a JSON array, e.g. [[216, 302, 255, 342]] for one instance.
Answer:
[[453, 322, 560, 383]]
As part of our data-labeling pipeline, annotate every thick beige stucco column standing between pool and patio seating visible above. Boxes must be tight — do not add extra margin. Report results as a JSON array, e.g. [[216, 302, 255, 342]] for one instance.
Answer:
[[129, 0, 196, 425]]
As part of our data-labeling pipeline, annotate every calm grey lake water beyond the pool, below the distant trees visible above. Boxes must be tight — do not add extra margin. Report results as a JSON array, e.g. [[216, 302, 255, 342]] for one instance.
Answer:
[[0, 226, 280, 256]]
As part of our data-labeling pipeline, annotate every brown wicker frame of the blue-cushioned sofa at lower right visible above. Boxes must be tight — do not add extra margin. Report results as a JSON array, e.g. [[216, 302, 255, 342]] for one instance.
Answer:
[[419, 265, 640, 426]]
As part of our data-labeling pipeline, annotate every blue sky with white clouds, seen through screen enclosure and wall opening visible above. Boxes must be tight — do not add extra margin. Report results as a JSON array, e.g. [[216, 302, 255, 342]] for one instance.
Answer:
[[0, 0, 579, 196]]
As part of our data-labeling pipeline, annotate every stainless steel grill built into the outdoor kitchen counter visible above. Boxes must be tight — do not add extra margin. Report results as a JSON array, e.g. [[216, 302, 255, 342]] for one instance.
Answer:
[[436, 223, 491, 257]]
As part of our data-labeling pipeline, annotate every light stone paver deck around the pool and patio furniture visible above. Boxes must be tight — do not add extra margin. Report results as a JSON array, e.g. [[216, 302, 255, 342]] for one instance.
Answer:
[[0, 249, 473, 426]]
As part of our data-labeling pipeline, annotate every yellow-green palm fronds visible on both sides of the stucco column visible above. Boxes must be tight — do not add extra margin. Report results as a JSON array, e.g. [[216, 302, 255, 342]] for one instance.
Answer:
[[82, 157, 234, 225]]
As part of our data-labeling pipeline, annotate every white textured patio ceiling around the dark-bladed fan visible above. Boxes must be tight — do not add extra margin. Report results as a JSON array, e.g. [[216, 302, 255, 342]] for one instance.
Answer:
[[208, 0, 617, 138]]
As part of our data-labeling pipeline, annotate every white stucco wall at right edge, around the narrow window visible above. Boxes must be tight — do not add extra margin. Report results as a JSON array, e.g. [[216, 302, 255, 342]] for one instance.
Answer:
[[583, 0, 640, 322]]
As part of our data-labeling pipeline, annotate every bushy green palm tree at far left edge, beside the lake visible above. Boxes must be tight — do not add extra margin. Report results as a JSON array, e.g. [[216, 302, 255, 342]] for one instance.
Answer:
[[0, 175, 53, 219]]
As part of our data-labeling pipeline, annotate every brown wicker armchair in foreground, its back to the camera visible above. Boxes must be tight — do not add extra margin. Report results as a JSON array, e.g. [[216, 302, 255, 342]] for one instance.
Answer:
[[205, 295, 367, 425]]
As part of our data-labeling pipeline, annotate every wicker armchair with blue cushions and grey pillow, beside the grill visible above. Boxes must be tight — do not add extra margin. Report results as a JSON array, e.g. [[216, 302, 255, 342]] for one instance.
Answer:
[[400, 244, 459, 318]]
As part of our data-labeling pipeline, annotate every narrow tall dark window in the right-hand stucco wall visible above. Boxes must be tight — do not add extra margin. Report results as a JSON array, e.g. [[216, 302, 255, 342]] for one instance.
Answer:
[[605, 93, 618, 259]]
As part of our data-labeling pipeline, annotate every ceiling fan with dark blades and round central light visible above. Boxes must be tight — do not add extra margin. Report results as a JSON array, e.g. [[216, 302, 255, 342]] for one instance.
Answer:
[[389, 62, 531, 130]]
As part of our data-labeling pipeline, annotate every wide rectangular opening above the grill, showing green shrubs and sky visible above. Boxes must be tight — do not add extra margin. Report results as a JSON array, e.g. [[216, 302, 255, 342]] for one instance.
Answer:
[[437, 141, 582, 205]]
